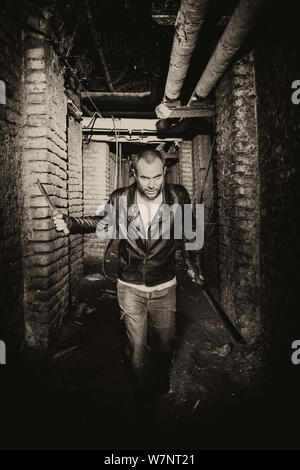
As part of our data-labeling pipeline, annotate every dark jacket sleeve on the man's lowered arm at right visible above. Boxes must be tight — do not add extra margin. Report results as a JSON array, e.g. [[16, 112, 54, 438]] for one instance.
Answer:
[[181, 188, 202, 275]]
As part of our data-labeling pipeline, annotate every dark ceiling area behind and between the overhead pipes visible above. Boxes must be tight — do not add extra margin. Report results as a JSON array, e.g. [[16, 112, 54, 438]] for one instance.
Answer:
[[49, 0, 241, 115]]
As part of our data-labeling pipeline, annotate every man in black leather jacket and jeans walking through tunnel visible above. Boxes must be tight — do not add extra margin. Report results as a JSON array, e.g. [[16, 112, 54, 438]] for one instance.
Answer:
[[53, 150, 203, 392]]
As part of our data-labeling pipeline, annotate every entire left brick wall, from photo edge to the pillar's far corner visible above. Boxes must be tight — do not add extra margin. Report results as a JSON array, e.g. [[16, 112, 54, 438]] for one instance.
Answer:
[[0, 4, 82, 350]]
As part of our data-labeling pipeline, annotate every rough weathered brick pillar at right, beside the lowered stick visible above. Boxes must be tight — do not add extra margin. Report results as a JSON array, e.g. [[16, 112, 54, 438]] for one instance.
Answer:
[[216, 54, 260, 341]]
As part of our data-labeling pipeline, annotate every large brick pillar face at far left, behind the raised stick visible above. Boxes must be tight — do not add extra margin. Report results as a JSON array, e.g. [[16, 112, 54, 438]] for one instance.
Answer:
[[23, 37, 70, 346]]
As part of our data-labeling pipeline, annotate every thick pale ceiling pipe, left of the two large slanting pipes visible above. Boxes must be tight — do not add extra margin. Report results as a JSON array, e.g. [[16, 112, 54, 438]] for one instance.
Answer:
[[164, 0, 210, 101]]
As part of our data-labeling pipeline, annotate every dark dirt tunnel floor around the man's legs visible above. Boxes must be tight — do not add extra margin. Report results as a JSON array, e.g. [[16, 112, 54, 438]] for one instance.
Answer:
[[1, 260, 296, 449]]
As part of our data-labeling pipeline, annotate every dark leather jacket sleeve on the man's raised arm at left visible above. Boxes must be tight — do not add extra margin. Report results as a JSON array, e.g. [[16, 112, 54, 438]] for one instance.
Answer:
[[64, 193, 115, 234]]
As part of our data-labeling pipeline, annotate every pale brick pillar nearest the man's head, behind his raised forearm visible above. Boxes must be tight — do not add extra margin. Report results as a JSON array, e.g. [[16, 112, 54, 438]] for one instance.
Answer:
[[83, 142, 110, 272]]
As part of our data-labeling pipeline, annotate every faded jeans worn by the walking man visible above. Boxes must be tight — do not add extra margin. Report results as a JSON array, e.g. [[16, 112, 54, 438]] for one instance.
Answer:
[[117, 283, 176, 386]]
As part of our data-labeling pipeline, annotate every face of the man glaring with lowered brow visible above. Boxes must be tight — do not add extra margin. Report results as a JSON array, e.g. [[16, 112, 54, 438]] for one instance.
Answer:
[[135, 158, 166, 199]]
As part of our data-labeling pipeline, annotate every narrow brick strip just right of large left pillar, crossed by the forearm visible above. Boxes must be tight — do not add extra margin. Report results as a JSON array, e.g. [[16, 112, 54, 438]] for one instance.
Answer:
[[67, 116, 83, 296]]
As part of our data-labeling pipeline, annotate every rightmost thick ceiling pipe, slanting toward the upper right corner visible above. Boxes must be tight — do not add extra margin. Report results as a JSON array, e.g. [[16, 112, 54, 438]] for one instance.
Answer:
[[192, 0, 267, 104]]
